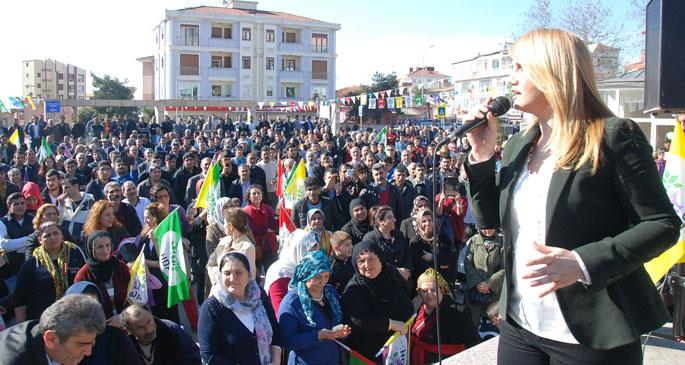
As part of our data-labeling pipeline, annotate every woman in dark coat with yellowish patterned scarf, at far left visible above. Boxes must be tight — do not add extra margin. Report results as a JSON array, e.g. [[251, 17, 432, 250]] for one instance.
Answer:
[[14, 221, 85, 322]]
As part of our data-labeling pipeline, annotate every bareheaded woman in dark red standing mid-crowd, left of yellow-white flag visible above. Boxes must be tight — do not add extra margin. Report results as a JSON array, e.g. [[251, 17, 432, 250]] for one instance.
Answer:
[[243, 185, 278, 272]]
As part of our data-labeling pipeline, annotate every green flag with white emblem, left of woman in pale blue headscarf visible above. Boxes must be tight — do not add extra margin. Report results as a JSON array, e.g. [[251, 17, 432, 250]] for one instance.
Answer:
[[154, 208, 190, 308]]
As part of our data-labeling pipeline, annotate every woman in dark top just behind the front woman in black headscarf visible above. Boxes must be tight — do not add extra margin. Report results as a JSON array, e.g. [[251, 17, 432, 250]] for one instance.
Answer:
[[364, 205, 412, 281]]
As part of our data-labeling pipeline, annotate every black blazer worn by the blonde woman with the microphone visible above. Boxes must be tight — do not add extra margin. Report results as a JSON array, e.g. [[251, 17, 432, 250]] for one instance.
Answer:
[[465, 117, 680, 349]]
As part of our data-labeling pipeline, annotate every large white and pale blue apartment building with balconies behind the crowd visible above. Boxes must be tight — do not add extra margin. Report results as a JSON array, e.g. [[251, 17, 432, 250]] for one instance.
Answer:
[[152, 1, 340, 101]]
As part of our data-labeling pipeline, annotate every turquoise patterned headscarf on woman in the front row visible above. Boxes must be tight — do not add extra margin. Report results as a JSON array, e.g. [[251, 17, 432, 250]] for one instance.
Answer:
[[288, 251, 342, 327]]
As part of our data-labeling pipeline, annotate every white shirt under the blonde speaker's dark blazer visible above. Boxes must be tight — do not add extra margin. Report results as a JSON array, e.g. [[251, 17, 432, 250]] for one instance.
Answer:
[[508, 158, 578, 344]]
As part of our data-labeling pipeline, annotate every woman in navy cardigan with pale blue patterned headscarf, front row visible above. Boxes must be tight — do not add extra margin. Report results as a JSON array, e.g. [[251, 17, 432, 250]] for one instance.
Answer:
[[198, 252, 282, 365]]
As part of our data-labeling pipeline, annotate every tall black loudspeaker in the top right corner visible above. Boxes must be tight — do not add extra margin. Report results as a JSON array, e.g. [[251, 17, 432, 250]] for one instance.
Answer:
[[645, 0, 685, 113]]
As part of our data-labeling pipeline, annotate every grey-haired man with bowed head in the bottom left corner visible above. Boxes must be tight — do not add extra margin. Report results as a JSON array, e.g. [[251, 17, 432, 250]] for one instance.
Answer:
[[0, 294, 105, 365]]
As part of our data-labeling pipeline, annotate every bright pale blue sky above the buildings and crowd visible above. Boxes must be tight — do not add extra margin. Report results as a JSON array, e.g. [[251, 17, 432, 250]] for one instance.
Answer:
[[0, 0, 634, 96]]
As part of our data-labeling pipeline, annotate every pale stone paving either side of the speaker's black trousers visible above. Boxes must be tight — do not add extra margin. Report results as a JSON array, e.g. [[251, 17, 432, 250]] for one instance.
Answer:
[[442, 323, 685, 365]]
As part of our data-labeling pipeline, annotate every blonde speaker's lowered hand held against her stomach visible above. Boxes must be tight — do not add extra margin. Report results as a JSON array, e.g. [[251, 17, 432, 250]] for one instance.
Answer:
[[523, 242, 584, 298]]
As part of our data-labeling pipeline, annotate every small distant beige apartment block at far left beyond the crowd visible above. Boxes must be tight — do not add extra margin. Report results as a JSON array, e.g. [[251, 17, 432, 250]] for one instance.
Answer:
[[22, 58, 86, 100]]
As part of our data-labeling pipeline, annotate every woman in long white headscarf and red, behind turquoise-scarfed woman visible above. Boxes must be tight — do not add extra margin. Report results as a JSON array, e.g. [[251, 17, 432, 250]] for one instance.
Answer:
[[264, 229, 319, 313]]
